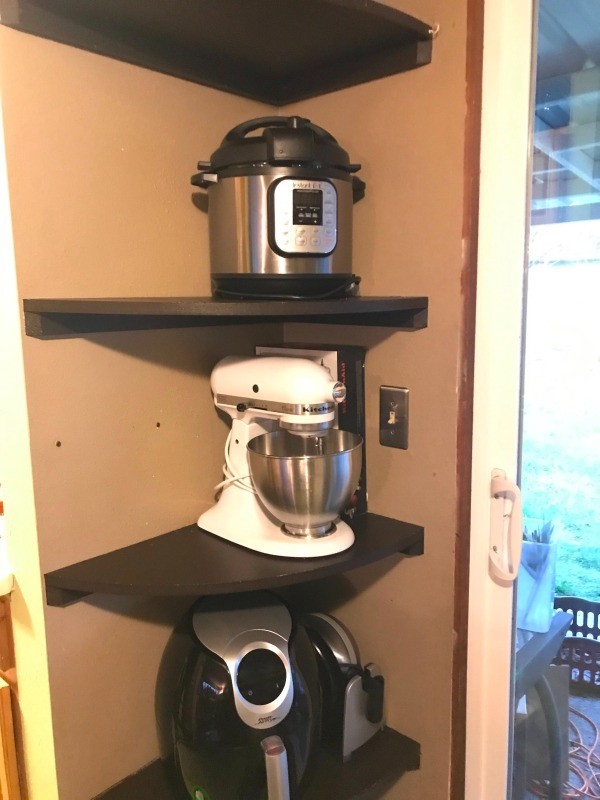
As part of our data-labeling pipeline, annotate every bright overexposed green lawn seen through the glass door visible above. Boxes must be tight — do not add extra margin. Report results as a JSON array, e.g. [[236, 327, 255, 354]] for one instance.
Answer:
[[521, 263, 600, 600]]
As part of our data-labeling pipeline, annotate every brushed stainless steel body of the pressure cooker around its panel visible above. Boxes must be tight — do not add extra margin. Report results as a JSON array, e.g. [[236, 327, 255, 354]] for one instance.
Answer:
[[208, 173, 353, 275]]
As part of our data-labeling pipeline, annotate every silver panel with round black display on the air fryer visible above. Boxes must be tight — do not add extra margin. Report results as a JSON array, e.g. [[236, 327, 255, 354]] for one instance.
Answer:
[[192, 594, 294, 730]]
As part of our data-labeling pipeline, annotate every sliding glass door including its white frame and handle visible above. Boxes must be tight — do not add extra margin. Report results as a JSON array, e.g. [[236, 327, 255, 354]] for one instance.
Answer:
[[465, 0, 600, 800]]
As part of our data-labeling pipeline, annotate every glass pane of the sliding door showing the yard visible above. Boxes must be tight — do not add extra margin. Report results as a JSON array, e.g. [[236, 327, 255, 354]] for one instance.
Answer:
[[509, 0, 600, 800]]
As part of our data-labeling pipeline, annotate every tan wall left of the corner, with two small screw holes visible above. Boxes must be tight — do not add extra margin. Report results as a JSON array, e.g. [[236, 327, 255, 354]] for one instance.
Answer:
[[0, 29, 279, 800]]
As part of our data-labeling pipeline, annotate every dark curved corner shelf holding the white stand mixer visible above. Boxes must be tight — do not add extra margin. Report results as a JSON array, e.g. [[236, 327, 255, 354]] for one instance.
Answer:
[[45, 513, 424, 606]]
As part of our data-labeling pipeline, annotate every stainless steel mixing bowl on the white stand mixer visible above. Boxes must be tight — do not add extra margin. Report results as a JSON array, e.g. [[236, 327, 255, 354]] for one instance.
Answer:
[[248, 429, 363, 536]]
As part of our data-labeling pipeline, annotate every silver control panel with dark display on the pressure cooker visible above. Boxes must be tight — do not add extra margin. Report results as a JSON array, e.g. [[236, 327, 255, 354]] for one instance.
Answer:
[[271, 178, 337, 255]]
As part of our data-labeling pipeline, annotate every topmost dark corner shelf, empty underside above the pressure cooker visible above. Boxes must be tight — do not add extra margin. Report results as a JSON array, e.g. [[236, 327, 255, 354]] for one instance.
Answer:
[[0, 0, 432, 106]]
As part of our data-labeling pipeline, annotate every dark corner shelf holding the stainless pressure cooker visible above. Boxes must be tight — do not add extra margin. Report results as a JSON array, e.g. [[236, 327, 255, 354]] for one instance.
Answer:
[[23, 297, 428, 339]]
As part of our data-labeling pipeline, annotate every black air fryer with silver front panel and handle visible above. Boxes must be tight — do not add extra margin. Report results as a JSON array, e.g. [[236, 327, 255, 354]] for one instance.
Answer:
[[157, 593, 320, 800]]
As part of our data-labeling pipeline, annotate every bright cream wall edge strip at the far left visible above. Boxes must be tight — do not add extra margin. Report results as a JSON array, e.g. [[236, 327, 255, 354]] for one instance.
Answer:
[[0, 86, 56, 800]]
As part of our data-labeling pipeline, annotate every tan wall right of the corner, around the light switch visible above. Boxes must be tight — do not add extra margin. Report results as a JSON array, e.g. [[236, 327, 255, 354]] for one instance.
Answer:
[[285, 0, 466, 800]]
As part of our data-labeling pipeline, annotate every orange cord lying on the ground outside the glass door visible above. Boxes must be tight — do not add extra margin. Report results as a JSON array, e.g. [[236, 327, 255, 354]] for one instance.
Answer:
[[527, 707, 600, 800]]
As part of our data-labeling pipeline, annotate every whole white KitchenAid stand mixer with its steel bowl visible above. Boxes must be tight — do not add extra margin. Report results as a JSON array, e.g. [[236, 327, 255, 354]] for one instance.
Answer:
[[198, 356, 362, 558]]
